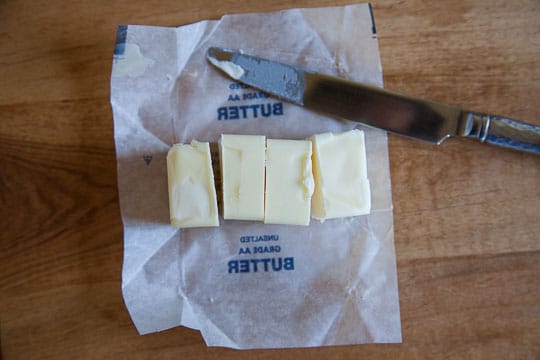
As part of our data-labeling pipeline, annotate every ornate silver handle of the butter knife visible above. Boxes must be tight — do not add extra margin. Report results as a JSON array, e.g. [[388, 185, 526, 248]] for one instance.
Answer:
[[463, 112, 540, 155]]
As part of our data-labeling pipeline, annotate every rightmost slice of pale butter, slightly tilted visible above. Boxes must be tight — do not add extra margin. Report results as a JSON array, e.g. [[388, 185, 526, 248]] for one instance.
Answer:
[[311, 130, 371, 221]]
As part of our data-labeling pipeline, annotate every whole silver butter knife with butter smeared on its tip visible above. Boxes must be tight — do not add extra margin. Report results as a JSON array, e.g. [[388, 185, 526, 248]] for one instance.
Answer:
[[207, 47, 540, 154]]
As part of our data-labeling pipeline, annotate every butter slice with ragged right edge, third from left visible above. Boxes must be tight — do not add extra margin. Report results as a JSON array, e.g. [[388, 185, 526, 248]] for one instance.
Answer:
[[264, 139, 314, 225]]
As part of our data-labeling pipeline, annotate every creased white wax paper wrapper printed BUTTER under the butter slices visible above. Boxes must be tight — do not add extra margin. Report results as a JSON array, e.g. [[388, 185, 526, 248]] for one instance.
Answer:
[[111, 4, 401, 349]]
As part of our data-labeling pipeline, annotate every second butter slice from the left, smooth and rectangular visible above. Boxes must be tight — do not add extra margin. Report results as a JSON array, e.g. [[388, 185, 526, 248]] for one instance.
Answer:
[[219, 135, 266, 221]]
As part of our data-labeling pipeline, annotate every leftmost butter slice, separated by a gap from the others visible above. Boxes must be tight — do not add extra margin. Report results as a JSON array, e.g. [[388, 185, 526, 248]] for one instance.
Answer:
[[167, 140, 219, 228]]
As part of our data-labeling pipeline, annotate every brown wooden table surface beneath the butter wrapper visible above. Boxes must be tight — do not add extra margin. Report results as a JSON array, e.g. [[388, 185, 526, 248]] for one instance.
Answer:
[[0, 0, 540, 359]]
